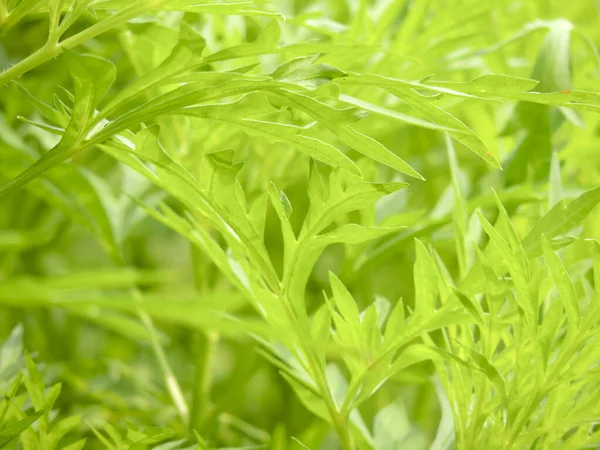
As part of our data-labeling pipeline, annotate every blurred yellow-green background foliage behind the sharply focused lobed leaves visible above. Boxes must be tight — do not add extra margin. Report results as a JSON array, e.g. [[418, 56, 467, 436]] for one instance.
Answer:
[[0, 0, 600, 448]]
